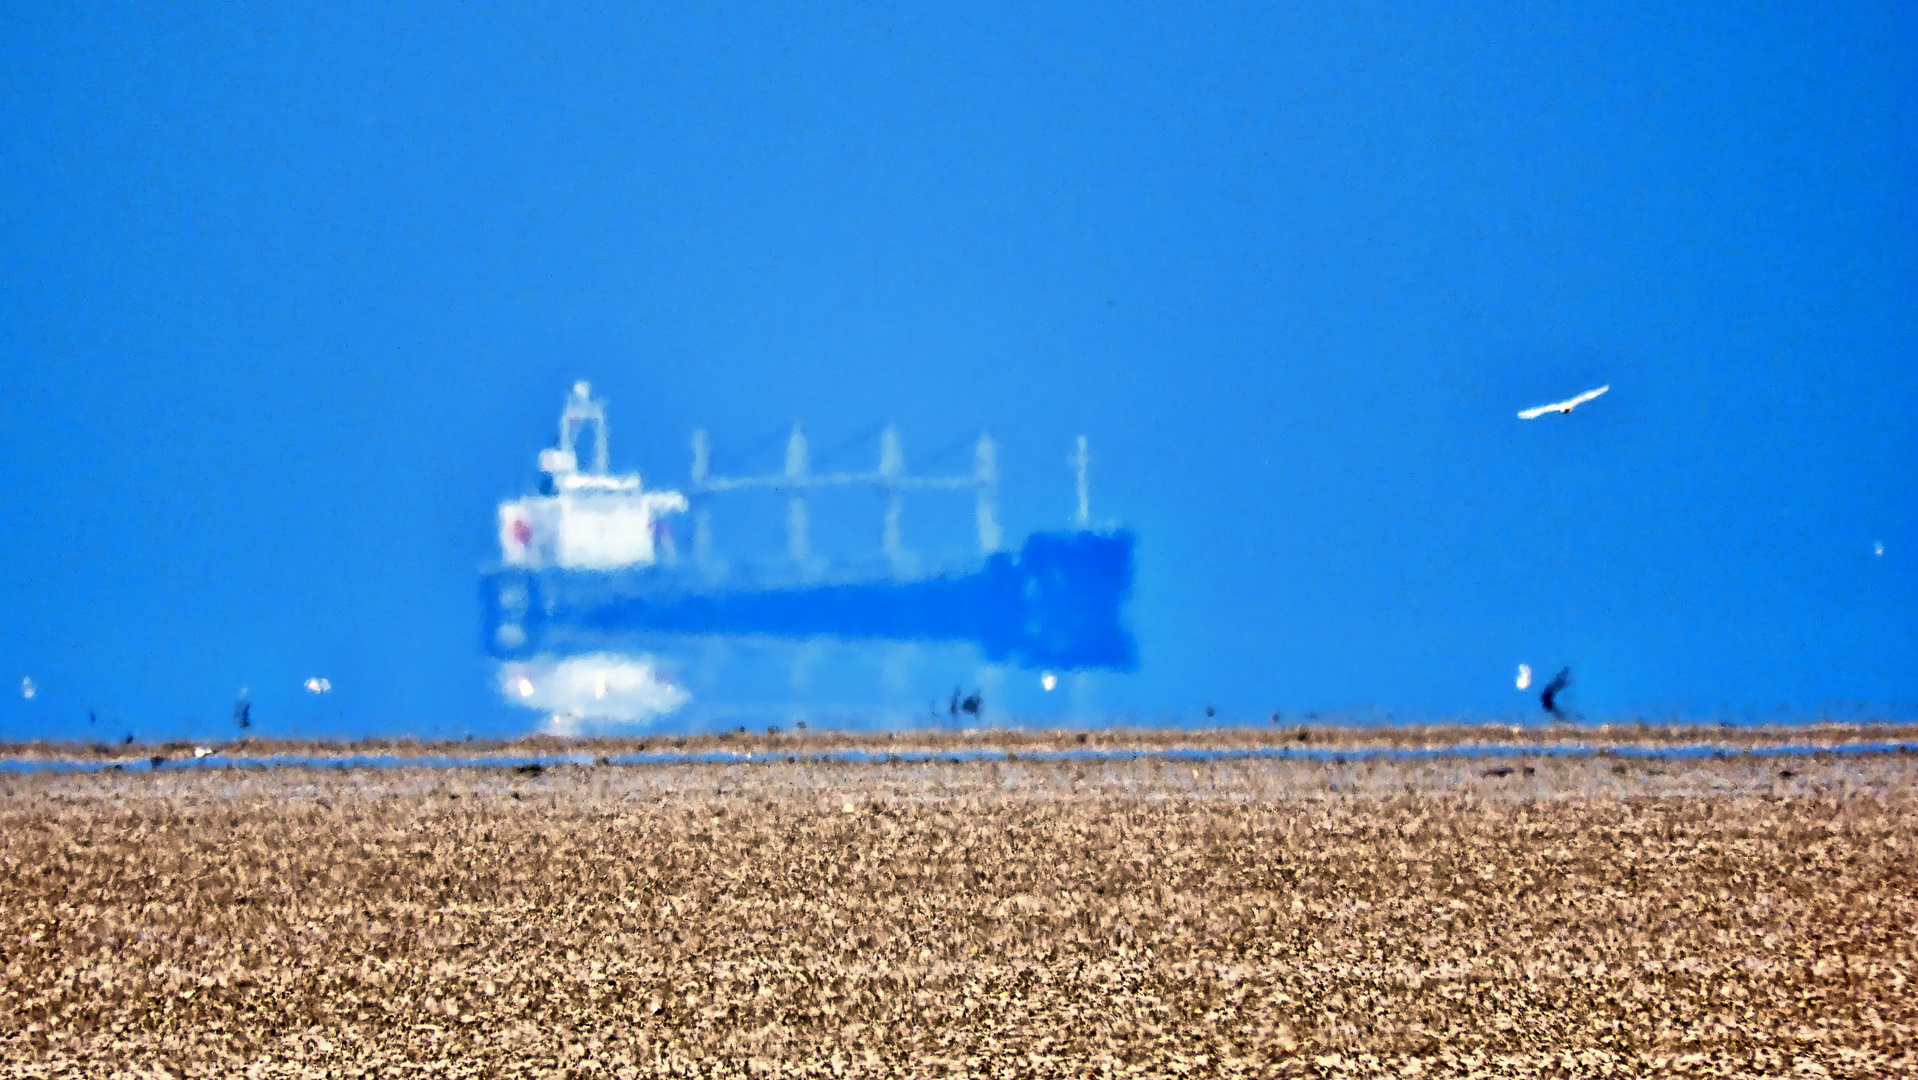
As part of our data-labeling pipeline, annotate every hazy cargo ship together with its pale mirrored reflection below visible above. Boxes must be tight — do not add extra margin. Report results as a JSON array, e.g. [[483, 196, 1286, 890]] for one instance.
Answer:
[[481, 384, 1137, 733]]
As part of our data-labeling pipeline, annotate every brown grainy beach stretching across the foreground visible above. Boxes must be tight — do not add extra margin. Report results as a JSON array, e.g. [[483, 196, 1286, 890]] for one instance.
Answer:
[[0, 729, 1918, 1076]]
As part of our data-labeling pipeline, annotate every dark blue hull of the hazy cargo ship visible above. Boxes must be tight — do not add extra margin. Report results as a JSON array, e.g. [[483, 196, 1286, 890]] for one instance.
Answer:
[[481, 531, 1139, 671]]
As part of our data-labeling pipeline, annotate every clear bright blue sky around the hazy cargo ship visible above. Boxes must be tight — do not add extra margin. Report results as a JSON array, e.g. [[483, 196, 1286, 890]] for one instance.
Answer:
[[0, 4, 1918, 739]]
